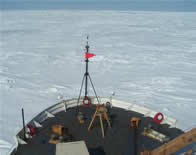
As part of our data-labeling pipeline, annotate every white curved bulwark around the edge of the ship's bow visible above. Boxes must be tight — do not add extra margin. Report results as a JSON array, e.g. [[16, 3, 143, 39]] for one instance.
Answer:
[[14, 97, 177, 147]]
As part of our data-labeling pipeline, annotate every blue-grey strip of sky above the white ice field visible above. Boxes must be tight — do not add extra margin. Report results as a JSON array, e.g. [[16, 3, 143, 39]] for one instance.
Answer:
[[0, 0, 196, 12]]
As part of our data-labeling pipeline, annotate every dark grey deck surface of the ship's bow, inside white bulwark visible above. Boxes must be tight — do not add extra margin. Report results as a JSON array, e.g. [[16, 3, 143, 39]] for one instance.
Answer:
[[12, 105, 183, 155]]
